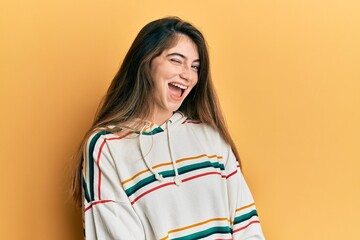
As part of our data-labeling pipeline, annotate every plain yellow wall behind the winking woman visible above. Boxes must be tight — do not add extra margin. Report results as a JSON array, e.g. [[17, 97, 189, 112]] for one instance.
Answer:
[[0, 0, 360, 240]]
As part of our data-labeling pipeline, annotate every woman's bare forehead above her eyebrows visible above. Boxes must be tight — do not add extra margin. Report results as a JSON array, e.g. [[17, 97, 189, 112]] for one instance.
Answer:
[[164, 34, 199, 61]]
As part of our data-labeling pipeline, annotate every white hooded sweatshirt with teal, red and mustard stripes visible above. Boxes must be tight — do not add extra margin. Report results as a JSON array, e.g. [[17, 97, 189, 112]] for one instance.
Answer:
[[83, 112, 264, 240]]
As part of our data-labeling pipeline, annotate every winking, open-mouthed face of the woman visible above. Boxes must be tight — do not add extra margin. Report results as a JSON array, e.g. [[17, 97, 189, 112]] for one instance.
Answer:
[[151, 35, 200, 125]]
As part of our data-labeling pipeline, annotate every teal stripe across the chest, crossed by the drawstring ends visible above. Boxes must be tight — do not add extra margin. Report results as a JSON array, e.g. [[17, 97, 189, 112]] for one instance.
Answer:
[[125, 161, 225, 197]]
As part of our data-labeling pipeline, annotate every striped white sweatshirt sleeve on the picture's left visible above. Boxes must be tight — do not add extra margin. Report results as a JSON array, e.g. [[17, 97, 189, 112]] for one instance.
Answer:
[[83, 132, 145, 240]]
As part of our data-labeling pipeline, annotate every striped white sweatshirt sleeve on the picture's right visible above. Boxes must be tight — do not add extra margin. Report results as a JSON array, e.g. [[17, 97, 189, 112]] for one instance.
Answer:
[[226, 147, 265, 240]]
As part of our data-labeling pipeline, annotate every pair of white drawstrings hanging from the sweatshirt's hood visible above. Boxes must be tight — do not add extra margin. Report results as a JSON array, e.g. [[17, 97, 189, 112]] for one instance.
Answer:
[[139, 117, 182, 186]]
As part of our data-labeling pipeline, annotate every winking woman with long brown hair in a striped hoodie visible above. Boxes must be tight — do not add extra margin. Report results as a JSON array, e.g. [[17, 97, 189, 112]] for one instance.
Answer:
[[73, 17, 264, 240]]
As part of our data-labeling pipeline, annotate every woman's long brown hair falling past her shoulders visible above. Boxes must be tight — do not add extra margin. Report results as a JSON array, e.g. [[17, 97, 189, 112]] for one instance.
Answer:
[[72, 17, 240, 203]]
